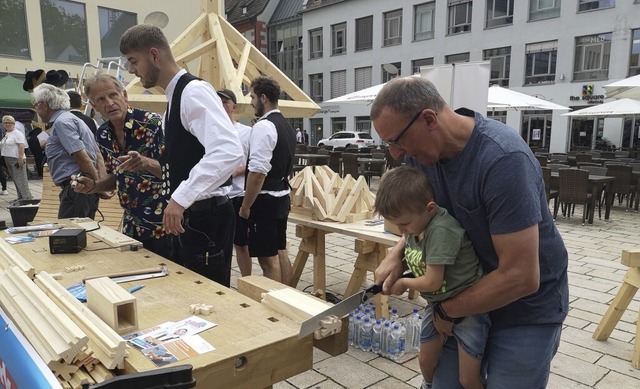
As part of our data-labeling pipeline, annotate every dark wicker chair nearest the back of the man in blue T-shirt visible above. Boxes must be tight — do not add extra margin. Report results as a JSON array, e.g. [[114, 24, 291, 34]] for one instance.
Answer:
[[553, 169, 593, 225]]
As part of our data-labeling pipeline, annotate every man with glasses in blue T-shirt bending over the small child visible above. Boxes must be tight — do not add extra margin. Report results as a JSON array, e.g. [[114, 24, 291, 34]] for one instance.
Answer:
[[371, 77, 569, 388]]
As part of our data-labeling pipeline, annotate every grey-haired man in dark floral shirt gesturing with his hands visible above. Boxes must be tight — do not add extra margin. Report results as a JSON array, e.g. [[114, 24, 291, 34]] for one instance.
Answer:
[[75, 74, 171, 259]]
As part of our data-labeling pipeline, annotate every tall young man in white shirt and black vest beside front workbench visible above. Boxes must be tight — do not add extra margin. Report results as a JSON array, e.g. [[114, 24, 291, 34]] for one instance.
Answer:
[[120, 24, 242, 286]]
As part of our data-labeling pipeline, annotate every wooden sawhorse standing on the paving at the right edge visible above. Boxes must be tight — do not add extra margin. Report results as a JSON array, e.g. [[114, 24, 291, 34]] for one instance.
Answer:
[[593, 249, 640, 369]]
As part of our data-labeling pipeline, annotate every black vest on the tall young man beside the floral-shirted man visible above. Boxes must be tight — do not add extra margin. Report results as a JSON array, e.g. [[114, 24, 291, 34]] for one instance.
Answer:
[[160, 73, 231, 196]]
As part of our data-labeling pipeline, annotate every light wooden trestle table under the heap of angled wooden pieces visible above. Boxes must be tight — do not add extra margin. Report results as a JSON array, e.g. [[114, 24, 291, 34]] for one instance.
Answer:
[[289, 212, 415, 318]]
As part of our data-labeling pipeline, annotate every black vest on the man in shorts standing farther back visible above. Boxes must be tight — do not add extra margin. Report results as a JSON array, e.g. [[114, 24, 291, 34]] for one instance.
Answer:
[[245, 112, 296, 192]]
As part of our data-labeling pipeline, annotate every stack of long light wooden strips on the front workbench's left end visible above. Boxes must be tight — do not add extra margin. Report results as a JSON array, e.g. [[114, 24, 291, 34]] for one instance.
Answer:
[[0, 264, 127, 389]]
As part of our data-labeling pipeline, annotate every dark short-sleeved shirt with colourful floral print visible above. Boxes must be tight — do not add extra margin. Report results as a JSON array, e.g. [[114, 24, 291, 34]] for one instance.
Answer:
[[96, 107, 167, 240]]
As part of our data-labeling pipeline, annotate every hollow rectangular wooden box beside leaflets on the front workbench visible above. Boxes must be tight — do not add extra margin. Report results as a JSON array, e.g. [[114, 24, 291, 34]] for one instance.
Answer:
[[85, 277, 138, 334]]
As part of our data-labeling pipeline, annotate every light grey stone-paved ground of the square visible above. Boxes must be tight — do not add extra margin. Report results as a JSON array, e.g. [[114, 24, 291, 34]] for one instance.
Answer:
[[5, 179, 640, 389]]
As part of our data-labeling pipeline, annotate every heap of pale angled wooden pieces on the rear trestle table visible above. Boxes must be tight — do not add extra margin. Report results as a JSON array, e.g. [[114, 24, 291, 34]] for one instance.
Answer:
[[291, 166, 375, 223]]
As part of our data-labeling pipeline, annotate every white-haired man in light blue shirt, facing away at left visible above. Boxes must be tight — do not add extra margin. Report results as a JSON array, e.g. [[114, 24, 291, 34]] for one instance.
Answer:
[[33, 84, 104, 219]]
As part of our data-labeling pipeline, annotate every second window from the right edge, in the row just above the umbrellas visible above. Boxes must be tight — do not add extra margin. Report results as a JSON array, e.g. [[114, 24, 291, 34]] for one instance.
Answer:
[[573, 33, 612, 81]]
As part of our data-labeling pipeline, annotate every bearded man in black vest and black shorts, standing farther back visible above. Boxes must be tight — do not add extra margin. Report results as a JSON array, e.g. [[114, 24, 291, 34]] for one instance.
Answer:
[[239, 76, 296, 284]]
